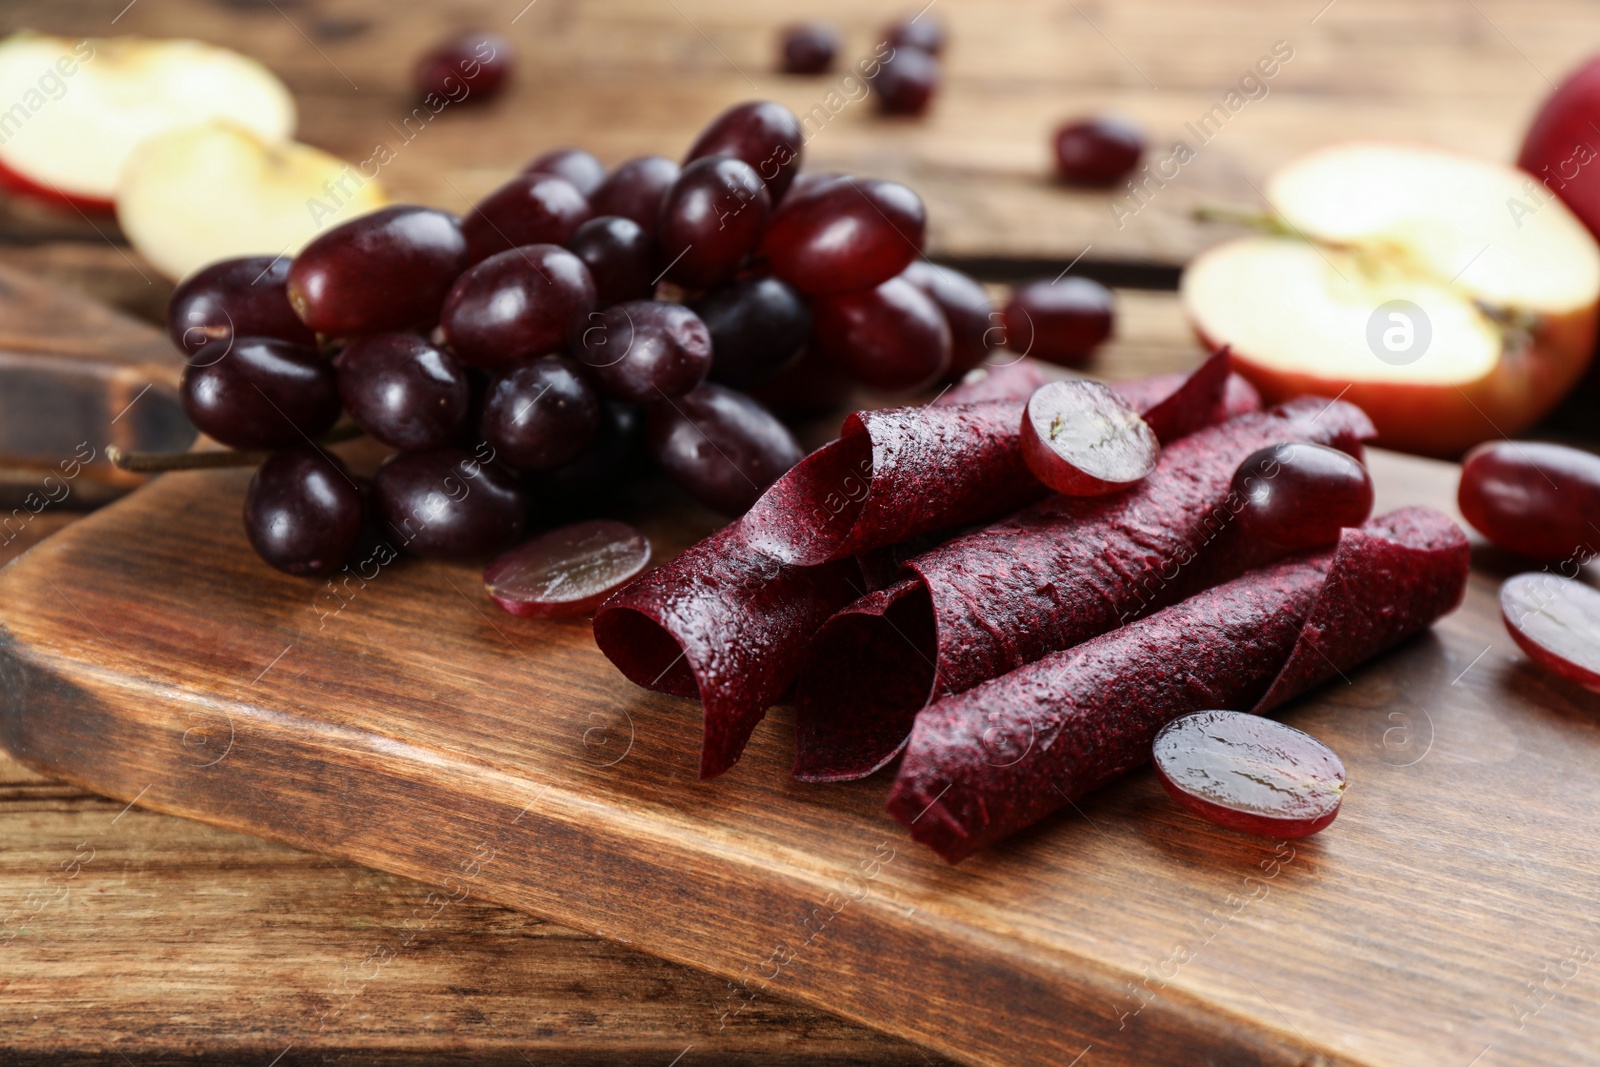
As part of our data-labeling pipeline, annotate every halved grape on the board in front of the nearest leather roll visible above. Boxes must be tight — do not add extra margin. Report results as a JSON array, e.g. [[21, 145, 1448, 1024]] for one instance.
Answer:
[[1150, 712, 1344, 838]]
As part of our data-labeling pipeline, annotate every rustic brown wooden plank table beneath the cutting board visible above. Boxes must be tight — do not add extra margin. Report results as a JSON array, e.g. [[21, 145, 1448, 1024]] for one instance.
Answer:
[[0, 0, 1600, 1067]]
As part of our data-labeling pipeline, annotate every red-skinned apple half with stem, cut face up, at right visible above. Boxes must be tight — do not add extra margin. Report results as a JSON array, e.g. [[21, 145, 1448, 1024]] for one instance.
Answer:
[[1179, 142, 1600, 456]]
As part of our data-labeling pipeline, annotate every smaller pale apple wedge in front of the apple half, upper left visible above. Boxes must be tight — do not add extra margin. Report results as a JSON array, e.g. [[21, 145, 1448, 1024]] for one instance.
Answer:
[[117, 122, 389, 278]]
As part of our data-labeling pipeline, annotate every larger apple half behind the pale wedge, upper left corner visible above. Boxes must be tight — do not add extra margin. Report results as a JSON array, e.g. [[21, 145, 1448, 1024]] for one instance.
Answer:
[[0, 30, 294, 211]]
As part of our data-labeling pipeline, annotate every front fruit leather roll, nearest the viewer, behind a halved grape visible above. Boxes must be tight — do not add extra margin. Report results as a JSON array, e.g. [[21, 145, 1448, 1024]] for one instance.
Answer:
[[888, 507, 1469, 862]]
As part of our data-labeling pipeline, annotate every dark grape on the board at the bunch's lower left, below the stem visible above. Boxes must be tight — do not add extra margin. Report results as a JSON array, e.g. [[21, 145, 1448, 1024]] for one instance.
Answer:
[[245, 445, 362, 577]]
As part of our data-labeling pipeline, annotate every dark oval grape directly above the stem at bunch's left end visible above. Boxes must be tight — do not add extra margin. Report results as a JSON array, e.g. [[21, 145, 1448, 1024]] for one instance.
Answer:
[[179, 338, 339, 448]]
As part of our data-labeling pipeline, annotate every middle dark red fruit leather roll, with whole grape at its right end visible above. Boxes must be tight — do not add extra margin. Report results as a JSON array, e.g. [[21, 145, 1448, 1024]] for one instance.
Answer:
[[794, 397, 1373, 781]]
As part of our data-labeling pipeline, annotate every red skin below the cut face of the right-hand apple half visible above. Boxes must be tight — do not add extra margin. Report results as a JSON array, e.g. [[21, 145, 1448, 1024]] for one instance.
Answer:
[[1190, 295, 1600, 459]]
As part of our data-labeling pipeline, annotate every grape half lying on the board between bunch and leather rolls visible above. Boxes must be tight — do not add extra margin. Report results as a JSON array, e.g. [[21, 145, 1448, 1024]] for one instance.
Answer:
[[483, 518, 650, 619]]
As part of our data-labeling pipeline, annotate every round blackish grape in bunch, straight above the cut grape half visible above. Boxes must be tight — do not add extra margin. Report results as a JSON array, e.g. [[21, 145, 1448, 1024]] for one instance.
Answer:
[[478, 355, 600, 470]]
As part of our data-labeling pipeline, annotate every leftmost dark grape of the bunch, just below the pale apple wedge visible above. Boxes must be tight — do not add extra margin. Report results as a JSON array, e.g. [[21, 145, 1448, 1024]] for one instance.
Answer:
[[166, 256, 317, 354]]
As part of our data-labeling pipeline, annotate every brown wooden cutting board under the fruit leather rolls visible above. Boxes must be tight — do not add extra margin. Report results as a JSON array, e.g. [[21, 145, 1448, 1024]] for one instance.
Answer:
[[0, 409, 1600, 1065]]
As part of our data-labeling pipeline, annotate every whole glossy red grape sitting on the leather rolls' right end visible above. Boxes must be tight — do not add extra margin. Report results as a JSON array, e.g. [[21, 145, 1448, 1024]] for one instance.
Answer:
[[1232, 442, 1373, 549]]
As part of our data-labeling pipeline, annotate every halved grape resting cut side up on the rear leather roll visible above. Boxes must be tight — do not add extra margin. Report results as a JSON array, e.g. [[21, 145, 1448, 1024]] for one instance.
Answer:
[[1022, 381, 1162, 496]]
